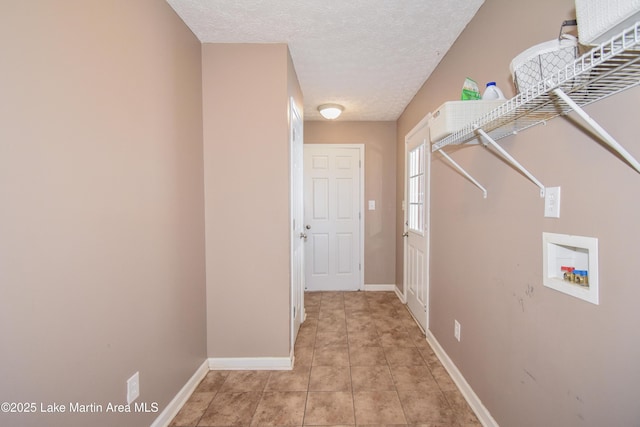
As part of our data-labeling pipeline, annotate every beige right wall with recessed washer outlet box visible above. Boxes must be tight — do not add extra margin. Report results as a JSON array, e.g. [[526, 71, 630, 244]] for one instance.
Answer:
[[396, 0, 640, 426]]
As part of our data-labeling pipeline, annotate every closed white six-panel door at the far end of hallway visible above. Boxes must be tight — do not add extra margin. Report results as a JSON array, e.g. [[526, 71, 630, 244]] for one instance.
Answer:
[[304, 144, 364, 291]]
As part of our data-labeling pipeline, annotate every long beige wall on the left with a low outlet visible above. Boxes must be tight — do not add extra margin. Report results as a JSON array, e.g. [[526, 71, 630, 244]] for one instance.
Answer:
[[0, 0, 206, 426]]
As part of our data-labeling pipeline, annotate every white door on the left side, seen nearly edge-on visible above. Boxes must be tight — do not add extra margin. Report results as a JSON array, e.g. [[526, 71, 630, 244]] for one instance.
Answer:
[[289, 99, 304, 348]]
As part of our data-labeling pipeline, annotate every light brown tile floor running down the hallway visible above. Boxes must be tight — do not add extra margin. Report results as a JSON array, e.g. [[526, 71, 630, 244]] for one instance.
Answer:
[[171, 292, 480, 427]]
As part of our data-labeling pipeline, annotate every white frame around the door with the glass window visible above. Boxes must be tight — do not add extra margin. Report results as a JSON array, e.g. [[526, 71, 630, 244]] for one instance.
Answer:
[[402, 113, 432, 332]]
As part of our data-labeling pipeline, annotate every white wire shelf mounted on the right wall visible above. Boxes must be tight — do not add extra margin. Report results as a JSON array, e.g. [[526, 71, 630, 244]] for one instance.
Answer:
[[431, 22, 640, 152]]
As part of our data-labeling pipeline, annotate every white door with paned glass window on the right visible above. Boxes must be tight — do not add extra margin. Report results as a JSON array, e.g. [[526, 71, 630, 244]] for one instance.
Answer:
[[404, 117, 431, 330]]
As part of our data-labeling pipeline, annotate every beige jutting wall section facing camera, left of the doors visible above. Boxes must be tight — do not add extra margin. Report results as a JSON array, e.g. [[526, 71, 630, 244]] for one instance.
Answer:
[[202, 44, 302, 358]]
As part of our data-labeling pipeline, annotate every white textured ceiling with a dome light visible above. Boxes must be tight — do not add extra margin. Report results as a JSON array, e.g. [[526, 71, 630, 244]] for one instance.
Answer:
[[167, 0, 484, 121]]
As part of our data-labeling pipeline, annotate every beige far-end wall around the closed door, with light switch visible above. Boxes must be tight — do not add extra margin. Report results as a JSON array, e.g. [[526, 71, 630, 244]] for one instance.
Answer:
[[304, 121, 401, 286]]
